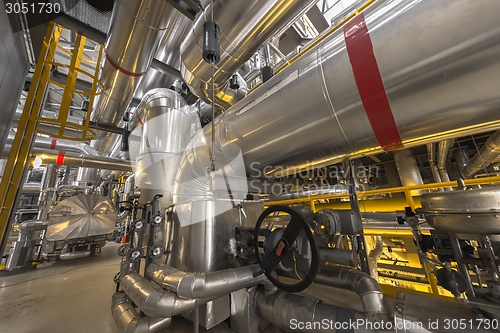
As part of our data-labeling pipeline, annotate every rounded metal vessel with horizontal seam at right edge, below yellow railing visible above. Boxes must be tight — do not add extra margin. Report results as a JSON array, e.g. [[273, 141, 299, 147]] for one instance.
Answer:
[[420, 188, 500, 235]]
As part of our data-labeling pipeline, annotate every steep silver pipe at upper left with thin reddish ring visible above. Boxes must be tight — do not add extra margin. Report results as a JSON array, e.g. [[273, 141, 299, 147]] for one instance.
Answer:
[[92, 0, 200, 155]]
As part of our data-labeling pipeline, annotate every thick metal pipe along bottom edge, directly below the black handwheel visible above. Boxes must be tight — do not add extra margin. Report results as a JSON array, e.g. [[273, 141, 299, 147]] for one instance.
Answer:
[[254, 288, 372, 333]]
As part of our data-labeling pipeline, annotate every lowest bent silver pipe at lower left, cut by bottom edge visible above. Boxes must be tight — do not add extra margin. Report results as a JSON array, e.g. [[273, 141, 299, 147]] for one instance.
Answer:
[[111, 292, 172, 333]]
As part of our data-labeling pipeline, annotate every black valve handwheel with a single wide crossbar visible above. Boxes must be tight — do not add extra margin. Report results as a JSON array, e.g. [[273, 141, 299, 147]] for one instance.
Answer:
[[254, 205, 319, 293]]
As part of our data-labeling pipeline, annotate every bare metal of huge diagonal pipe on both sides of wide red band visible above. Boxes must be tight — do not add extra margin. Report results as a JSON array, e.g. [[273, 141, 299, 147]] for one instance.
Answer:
[[175, 0, 500, 180]]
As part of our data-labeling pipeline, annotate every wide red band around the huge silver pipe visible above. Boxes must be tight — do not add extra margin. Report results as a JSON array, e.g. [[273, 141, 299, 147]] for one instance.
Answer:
[[344, 14, 404, 151]]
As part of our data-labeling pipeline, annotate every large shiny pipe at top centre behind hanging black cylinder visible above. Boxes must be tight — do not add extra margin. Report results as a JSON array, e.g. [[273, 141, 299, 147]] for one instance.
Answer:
[[181, 0, 317, 109]]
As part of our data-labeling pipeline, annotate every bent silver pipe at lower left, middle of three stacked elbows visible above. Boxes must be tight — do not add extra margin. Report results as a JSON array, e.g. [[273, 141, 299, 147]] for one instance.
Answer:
[[120, 273, 221, 318]]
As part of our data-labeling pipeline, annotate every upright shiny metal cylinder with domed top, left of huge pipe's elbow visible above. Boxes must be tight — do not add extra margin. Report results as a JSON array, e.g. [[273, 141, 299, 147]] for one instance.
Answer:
[[135, 88, 200, 211]]
